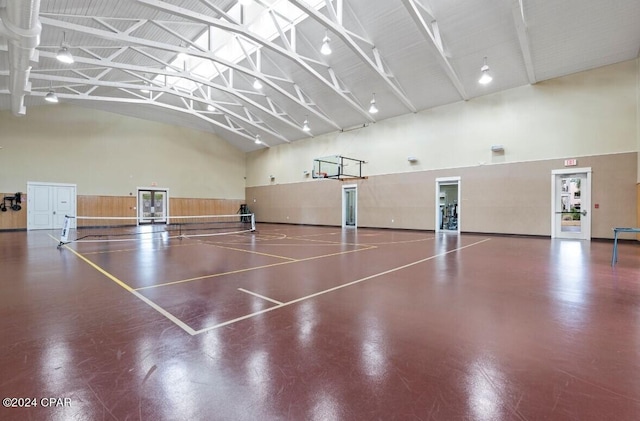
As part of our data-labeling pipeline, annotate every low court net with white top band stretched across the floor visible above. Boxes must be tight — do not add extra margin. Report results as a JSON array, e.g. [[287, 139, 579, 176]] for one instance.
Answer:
[[60, 213, 256, 245]]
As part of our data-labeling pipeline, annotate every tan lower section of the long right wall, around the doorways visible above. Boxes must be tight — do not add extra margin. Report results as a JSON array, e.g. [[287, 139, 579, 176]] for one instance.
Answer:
[[247, 152, 637, 238]]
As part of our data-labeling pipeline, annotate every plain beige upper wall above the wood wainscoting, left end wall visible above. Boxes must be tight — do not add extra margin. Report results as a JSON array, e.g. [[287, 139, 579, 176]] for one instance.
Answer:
[[0, 104, 245, 199]]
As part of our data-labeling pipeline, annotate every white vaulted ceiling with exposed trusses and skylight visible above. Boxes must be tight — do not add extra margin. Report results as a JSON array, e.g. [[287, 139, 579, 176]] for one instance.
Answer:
[[0, 0, 640, 151]]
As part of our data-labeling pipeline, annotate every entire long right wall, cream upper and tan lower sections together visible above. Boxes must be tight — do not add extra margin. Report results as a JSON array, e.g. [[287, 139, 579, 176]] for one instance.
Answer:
[[246, 60, 640, 238]]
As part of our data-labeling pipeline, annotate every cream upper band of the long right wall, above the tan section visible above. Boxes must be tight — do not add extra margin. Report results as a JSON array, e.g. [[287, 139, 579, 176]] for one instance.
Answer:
[[247, 60, 640, 187]]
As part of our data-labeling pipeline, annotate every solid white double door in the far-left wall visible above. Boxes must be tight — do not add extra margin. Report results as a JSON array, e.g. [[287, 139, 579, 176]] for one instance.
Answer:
[[27, 182, 76, 230]]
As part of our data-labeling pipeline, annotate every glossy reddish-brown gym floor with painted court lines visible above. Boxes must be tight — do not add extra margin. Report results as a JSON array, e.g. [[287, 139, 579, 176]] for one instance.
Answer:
[[0, 225, 640, 421]]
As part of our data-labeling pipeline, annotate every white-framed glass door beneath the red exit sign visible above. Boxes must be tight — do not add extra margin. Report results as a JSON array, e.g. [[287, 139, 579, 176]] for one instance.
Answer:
[[551, 168, 591, 240]]
